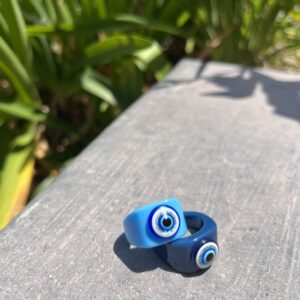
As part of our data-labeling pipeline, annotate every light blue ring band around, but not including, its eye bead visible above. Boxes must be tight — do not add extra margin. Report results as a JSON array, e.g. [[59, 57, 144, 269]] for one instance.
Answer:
[[123, 198, 187, 248]]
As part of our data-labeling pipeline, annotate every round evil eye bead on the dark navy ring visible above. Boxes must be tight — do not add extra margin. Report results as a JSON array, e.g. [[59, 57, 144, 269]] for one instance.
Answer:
[[195, 242, 219, 269]]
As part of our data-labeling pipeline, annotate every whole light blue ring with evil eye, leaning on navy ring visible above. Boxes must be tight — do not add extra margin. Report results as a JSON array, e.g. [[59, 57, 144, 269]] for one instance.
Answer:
[[123, 198, 187, 248]]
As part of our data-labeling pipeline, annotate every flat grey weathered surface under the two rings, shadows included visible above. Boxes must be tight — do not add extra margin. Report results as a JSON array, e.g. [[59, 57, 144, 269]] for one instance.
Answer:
[[0, 60, 300, 299]]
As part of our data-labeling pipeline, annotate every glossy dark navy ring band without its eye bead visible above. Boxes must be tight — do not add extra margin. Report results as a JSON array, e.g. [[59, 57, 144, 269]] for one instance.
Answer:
[[155, 212, 218, 274]]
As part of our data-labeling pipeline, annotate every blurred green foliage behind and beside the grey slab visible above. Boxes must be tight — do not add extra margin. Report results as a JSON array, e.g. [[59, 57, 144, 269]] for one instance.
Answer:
[[0, 0, 300, 228]]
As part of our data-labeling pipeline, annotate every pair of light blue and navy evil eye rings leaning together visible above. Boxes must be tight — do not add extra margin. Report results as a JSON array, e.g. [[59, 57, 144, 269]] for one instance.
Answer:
[[124, 199, 219, 274]]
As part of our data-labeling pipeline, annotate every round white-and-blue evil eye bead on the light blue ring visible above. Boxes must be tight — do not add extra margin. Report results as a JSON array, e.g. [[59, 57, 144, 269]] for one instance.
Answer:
[[151, 206, 180, 238]]
